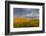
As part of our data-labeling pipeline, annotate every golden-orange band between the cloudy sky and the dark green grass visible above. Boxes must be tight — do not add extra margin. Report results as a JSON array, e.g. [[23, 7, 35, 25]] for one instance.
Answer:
[[14, 17, 38, 23]]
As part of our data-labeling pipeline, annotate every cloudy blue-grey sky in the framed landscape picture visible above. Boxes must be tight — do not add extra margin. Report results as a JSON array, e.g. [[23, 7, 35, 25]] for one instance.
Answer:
[[13, 8, 39, 17]]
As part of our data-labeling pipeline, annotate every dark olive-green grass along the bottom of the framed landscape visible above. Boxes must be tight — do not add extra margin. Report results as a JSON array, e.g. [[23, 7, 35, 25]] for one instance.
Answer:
[[13, 19, 39, 28]]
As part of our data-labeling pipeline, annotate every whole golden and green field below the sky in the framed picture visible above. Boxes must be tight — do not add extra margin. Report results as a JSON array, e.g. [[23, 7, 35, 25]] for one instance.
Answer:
[[13, 17, 39, 28]]
